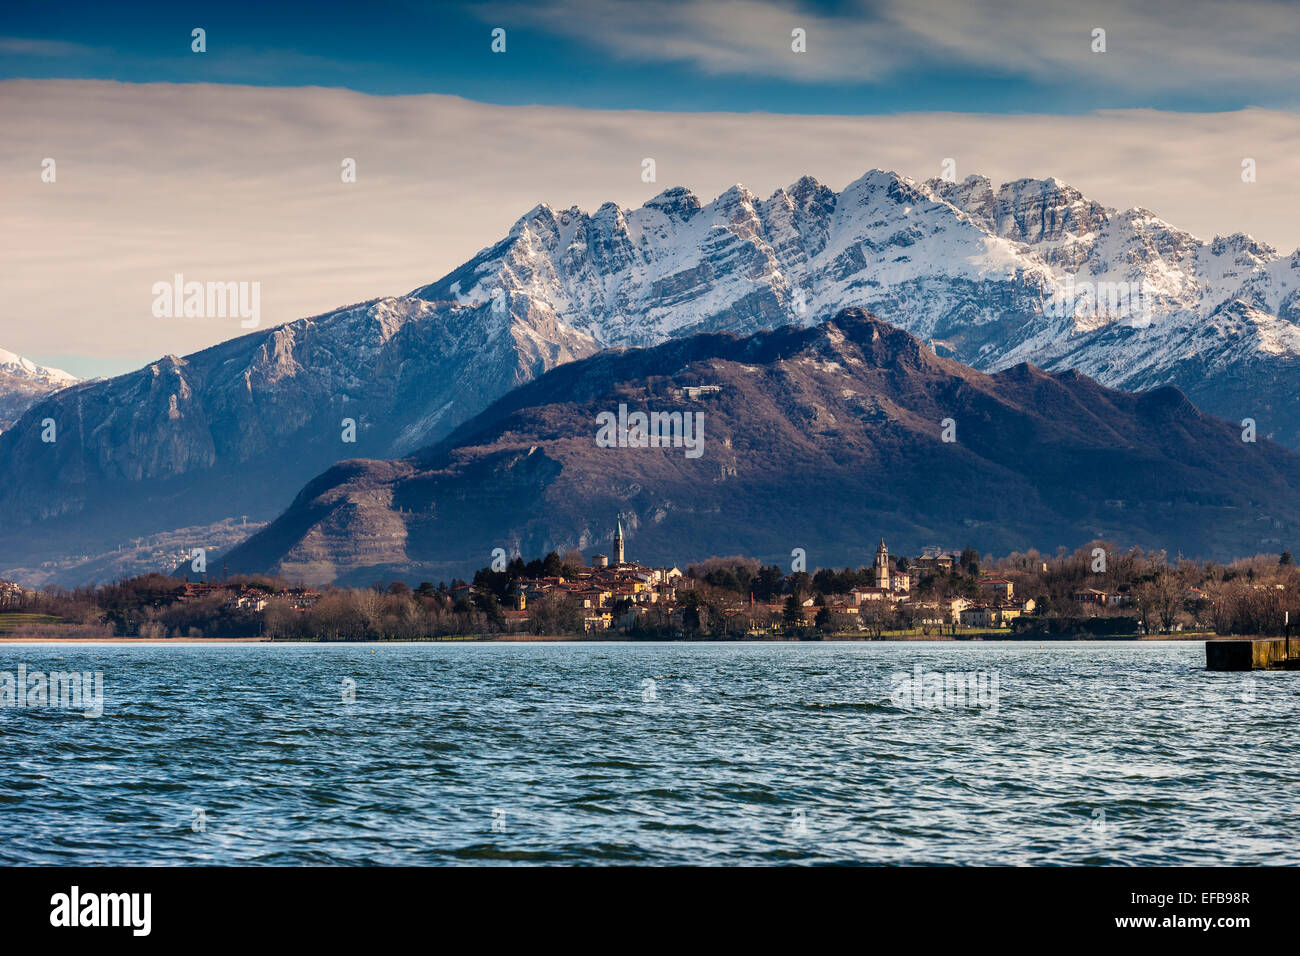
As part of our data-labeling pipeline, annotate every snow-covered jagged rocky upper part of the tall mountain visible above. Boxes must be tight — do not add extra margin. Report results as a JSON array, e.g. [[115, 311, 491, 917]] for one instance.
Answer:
[[415, 170, 1300, 447]]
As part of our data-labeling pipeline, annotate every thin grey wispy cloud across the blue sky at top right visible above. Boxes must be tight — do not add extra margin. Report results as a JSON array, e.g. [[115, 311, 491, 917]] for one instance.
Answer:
[[476, 0, 1300, 92]]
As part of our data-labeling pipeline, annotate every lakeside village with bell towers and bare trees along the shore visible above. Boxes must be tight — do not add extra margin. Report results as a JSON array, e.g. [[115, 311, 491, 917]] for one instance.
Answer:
[[0, 522, 1300, 640]]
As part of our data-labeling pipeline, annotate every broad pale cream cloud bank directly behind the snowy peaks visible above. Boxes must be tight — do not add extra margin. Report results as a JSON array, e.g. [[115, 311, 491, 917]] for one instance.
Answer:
[[0, 81, 1300, 371]]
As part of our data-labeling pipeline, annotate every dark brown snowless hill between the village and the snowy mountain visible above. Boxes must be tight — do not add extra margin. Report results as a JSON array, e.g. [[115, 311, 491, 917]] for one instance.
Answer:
[[228, 310, 1300, 583]]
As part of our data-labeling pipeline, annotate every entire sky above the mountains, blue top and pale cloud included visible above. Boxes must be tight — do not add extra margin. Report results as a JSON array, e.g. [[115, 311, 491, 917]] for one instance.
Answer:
[[0, 0, 1300, 375]]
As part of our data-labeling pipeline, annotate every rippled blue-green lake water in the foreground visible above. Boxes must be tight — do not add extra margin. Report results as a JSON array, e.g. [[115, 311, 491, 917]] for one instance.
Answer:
[[0, 643, 1300, 865]]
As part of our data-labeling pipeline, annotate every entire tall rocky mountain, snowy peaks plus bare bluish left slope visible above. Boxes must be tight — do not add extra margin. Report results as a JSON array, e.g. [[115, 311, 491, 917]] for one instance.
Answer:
[[0, 170, 1300, 580]]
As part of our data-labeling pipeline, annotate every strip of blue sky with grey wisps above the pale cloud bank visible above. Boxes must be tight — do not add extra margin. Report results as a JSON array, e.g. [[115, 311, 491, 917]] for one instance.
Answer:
[[0, 0, 1300, 114]]
